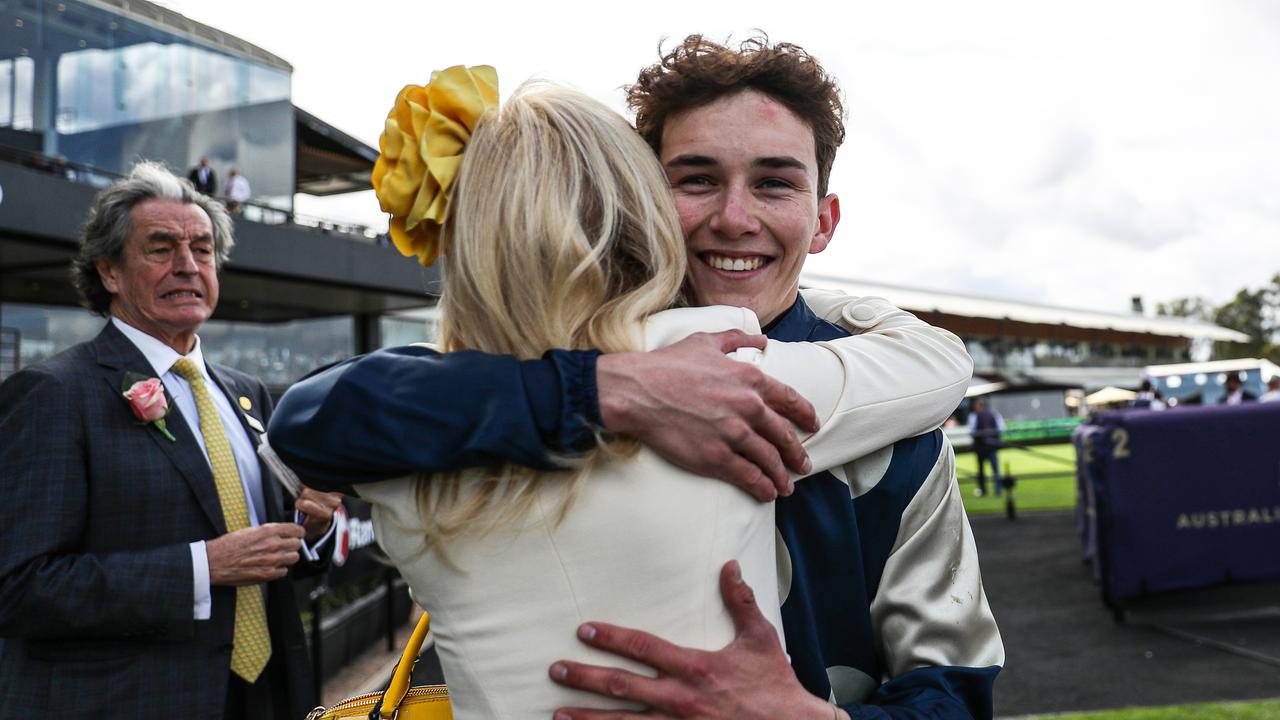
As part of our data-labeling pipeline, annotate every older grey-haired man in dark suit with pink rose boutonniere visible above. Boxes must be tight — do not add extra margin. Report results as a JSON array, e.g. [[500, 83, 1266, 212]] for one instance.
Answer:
[[0, 163, 339, 720]]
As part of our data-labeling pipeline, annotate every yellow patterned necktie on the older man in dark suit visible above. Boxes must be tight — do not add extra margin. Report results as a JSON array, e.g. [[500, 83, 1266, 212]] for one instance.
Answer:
[[173, 357, 271, 683]]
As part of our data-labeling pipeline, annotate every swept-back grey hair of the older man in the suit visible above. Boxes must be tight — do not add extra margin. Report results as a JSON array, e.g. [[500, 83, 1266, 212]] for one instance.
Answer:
[[72, 160, 236, 315]]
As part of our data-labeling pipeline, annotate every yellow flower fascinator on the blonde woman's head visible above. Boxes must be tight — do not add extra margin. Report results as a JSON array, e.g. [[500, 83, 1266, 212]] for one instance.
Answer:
[[372, 65, 498, 265]]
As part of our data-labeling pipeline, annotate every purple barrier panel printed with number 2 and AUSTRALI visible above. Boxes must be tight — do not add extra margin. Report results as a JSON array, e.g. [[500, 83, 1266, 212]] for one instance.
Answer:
[[1087, 404, 1280, 600]]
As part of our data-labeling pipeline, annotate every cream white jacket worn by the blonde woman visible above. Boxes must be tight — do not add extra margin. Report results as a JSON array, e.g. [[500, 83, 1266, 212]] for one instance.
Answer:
[[357, 291, 998, 720]]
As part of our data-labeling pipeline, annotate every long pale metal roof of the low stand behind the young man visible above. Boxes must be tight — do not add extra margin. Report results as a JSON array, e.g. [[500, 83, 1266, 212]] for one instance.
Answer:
[[800, 273, 1249, 342]]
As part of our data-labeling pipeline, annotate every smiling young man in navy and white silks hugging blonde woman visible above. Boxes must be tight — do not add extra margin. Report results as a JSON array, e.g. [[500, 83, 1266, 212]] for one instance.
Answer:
[[271, 36, 1004, 720]]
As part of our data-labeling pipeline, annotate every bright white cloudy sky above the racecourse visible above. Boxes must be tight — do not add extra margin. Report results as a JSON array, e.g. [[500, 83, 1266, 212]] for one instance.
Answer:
[[163, 0, 1280, 311]]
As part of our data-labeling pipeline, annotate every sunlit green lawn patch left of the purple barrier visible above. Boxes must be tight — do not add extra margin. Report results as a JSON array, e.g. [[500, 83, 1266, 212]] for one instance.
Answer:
[[956, 443, 1075, 515]]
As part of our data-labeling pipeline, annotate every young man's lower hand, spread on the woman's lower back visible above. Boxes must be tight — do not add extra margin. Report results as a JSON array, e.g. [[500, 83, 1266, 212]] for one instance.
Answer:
[[550, 561, 849, 720]]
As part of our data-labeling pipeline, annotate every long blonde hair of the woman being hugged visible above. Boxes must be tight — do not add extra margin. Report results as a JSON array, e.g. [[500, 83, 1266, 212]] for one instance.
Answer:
[[417, 81, 685, 550]]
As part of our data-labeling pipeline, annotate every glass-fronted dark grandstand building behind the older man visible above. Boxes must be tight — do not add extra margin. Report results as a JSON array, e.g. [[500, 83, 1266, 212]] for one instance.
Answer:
[[0, 0, 436, 392]]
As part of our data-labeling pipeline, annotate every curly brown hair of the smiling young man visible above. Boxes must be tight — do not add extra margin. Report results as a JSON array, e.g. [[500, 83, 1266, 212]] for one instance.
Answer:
[[626, 35, 845, 197]]
